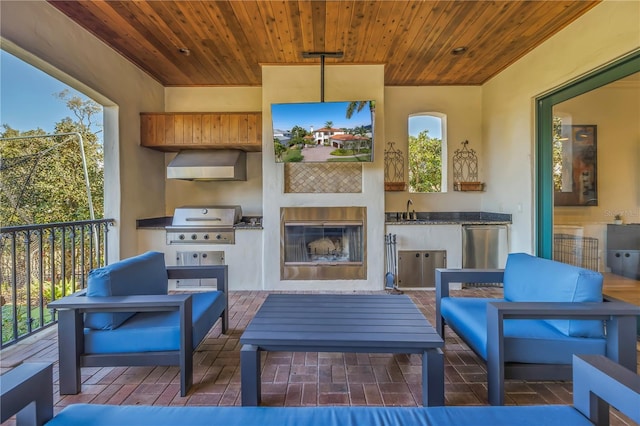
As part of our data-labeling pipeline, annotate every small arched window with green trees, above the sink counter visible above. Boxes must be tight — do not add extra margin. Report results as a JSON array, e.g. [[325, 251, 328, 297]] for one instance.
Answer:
[[408, 112, 447, 192]]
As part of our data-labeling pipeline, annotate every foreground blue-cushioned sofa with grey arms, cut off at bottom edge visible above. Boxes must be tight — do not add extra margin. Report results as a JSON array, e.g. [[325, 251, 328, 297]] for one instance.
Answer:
[[0, 355, 640, 426]]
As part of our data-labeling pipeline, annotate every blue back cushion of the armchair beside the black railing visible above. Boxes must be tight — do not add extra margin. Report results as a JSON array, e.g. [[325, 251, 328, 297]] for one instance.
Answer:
[[84, 251, 169, 330]]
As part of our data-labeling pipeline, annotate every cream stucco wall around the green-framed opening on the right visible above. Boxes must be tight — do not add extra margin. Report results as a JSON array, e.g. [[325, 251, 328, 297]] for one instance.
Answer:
[[482, 0, 640, 253]]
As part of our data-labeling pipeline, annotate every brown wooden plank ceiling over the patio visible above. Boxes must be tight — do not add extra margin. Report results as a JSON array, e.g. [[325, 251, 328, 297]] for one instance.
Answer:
[[50, 0, 600, 86]]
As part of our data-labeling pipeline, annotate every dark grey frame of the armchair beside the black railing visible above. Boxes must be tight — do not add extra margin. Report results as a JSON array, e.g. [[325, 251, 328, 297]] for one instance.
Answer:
[[48, 265, 229, 396]]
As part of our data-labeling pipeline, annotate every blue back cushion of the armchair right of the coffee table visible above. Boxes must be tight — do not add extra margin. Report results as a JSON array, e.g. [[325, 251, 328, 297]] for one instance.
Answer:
[[503, 253, 604, 337]]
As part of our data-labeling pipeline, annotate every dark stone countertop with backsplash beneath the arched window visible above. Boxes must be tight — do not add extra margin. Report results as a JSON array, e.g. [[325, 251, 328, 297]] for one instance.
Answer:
[[385, 212, 511, 225]]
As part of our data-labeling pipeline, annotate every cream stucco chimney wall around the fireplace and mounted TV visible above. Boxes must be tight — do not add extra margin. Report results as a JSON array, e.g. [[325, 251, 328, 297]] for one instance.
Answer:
[[262, 65, 385, 291]]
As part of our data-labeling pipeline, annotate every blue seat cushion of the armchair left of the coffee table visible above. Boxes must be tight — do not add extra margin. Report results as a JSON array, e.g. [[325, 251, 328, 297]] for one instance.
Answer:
[[84, 291, 226, 354]]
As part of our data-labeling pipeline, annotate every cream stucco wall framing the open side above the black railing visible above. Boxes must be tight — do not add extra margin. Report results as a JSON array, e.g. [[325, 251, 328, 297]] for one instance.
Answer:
[[0, 1, 164, 261]]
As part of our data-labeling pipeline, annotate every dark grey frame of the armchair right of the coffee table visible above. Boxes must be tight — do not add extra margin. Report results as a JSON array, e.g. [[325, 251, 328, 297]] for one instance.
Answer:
[[436, 268, 640, 405]]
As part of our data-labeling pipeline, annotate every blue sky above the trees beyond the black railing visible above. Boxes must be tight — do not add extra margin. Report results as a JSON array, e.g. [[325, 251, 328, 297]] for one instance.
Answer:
[[0, 50, 102, 133]]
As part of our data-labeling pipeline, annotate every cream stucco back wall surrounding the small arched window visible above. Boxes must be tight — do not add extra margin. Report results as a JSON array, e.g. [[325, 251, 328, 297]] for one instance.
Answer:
[[385, 86, 482, 211]]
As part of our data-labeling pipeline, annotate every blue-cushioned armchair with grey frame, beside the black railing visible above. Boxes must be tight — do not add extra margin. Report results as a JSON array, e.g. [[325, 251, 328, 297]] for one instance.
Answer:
[[48, 252, 228, 396]]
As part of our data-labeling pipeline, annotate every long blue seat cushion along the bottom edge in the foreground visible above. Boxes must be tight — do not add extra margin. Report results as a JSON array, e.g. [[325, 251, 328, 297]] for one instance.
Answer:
[[47, 404, 592, 426]]
